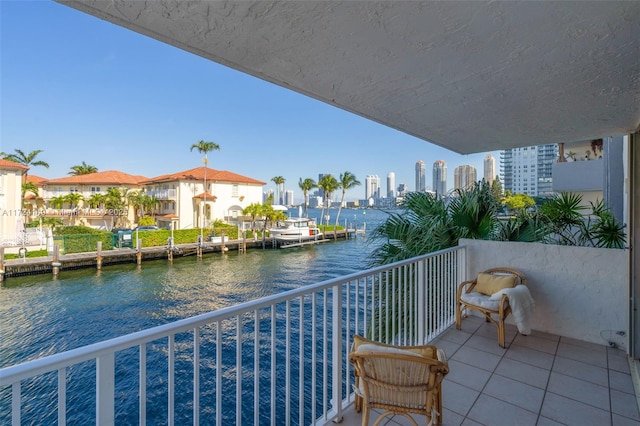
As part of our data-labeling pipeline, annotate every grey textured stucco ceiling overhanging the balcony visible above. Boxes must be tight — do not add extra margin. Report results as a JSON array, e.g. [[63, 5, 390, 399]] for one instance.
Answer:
[[61, 0, 640, 153]]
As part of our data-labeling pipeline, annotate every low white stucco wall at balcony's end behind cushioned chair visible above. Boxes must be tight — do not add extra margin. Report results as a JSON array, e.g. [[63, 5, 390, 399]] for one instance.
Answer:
[[460, 239, 629, 348]]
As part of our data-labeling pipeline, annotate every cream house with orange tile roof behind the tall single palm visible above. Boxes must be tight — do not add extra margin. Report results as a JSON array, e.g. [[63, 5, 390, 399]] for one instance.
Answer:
[[143, 167, 265, 229]]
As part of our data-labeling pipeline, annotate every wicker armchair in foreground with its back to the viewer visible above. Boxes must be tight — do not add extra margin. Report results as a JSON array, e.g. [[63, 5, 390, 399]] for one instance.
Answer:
[[349, 336, 449, 426]]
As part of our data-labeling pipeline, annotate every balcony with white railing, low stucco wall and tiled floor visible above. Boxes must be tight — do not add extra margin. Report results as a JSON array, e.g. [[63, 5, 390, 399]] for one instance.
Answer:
[[0, 240, 640, 425]]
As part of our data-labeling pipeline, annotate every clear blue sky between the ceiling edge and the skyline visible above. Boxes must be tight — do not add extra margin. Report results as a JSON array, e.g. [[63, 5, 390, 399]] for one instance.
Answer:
[[0, 0, 499, 202]]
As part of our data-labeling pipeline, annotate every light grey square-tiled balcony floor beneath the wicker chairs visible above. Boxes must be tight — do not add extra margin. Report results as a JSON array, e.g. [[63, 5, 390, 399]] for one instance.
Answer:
[[341, 317, 640, 426]]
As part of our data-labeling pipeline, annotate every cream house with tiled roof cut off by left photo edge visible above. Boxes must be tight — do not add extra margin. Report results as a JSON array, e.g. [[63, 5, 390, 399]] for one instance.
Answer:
[[0, 159, 29, 246]]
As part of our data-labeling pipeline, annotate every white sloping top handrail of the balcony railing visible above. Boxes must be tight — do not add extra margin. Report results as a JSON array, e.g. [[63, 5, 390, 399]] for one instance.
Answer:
[[0, 246, 464, 386]]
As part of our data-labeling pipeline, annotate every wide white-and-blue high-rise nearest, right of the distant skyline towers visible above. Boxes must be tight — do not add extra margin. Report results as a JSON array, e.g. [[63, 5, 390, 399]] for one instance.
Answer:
[[500, 144, 558, 197]]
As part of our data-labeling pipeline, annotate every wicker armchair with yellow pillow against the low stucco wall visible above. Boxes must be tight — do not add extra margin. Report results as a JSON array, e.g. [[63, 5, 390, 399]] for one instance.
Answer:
[[456, 268, 527, 348]]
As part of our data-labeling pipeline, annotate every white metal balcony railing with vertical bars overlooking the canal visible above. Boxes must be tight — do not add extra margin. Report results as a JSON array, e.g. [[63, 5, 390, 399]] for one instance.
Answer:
[[0, 247, 466, 425]]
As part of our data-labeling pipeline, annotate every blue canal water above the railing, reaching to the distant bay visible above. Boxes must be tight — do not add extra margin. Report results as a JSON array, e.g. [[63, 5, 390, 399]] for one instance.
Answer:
[[0, 210, 387, 424]]
